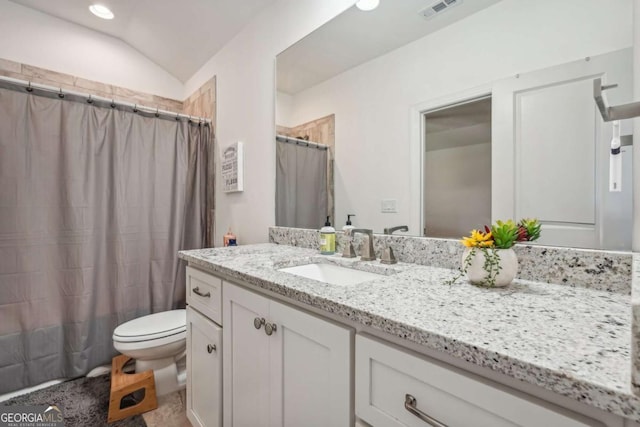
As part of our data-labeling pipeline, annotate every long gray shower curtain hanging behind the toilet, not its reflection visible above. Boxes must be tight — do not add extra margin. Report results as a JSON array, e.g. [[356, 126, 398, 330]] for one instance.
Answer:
[[0, 83, 213, 393]]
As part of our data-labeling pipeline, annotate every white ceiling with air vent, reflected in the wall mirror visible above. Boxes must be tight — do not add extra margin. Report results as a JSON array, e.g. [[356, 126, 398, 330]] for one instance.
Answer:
[[277, 0, 500, 95]]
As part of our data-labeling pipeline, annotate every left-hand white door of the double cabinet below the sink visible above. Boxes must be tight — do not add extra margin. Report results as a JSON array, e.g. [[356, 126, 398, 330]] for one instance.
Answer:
[[222, 282, 270, 427]]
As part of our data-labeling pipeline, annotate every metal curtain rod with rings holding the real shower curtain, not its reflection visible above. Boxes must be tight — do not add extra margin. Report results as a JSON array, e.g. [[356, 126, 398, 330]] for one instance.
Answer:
[[0, 76, 211, 124]]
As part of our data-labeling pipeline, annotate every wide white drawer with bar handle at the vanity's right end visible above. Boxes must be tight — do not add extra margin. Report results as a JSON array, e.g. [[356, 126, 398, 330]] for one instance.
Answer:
[[356, 335, 602, 427]]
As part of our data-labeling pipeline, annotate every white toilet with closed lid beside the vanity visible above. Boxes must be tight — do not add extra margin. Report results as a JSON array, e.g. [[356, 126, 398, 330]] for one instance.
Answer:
[[113, 310, 187, 396]]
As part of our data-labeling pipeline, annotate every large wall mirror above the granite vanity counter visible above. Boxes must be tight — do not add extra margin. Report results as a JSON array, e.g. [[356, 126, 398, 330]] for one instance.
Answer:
[[276, 0, 633, 250]]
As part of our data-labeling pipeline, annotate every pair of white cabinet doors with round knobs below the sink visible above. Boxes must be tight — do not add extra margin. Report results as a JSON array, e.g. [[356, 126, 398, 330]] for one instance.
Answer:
[[222, 282, 354, 427]]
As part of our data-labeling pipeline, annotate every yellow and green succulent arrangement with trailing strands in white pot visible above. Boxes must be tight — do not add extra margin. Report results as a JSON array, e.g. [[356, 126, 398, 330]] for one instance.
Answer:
[[447, 218, 542, 287]]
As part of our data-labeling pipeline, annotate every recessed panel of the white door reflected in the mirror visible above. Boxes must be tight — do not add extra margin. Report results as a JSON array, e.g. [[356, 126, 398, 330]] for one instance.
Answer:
[[514, 77, 598, 227]]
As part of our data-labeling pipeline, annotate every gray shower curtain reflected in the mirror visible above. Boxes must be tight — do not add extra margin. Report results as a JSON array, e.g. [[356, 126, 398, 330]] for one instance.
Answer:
[[276, 141, 328, 228]]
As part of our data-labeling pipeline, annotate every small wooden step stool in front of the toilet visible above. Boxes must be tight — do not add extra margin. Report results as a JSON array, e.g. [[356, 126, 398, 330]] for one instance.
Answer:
[[108, 354, 158, 423]]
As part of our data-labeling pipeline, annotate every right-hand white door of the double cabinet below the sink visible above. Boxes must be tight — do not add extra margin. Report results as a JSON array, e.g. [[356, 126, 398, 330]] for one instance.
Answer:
[[269, 301, 353, 427]]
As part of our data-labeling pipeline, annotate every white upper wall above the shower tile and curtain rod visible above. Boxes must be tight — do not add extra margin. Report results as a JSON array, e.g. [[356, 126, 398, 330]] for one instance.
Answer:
[[0, 0, 185, 100]]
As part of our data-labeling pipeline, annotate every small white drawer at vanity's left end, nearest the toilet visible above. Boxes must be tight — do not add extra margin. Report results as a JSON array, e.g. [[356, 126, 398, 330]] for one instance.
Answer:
[[187, 266, 222, 325]]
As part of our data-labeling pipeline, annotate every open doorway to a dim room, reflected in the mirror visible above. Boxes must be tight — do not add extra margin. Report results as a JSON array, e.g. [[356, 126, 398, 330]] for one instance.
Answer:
[[423, 97, 491, 238]]
